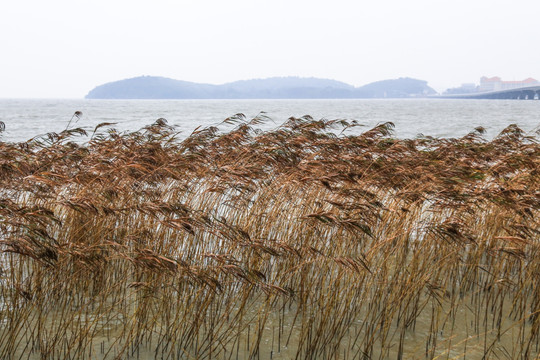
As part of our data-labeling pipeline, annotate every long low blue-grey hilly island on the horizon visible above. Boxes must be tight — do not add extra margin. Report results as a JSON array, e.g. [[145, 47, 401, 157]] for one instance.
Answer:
[[85, 76, 436, 99]]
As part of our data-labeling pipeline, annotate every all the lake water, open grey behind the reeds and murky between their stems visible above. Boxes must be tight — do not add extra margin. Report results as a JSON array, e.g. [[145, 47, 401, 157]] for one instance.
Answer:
[[0, 99, 540, 359]]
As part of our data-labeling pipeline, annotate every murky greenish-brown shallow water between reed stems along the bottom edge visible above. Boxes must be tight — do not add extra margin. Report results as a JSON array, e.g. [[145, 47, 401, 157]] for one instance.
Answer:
[[0, 295, 539, 360]]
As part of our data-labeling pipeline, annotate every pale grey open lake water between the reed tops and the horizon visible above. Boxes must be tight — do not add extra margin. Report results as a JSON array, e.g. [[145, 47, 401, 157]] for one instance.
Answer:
[[0, 99, 540, 141]]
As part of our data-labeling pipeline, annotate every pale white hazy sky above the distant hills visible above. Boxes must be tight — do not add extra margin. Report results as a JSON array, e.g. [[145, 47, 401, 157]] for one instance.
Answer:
[[0, 0, 540, 98]]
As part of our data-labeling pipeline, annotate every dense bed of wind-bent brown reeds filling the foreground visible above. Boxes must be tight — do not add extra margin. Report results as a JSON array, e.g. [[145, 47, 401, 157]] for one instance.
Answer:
[[0, 114, 540, 359]]
